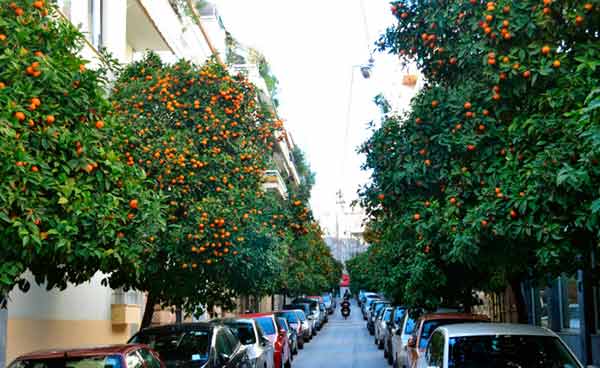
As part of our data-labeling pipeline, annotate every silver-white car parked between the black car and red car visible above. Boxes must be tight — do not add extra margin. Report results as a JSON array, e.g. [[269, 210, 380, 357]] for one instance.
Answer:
[[223, 318, 275, 368]]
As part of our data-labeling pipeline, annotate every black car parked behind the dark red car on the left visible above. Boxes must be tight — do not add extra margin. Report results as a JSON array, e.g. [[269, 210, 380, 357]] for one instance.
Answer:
[[129, 322, 250, 368]]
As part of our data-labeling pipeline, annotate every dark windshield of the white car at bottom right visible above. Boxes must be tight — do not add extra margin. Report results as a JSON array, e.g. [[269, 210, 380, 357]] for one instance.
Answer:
[[448, 335, 581, 368]]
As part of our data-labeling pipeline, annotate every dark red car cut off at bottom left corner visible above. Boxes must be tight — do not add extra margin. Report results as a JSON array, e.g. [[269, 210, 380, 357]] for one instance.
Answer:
[[8, 344, 165, 368]]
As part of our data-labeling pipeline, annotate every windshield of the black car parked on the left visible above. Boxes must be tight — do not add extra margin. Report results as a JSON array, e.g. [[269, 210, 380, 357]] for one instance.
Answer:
[[131, 330, 211, 367]]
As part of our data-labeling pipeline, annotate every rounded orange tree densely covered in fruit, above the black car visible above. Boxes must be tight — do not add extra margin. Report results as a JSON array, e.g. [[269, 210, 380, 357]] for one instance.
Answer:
[[111, 54, 285, 325]]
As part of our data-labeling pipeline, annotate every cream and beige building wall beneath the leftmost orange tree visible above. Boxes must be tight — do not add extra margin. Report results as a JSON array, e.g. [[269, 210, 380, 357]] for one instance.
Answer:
[[7, 273, 142, 362]]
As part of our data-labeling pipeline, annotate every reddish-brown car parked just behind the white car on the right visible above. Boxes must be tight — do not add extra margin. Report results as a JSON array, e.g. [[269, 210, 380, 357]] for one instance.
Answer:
[[405, 313, 490, 367]]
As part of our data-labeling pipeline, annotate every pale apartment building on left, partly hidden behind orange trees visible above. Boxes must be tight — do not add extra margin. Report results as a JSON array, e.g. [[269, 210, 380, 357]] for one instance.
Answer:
[[0, 0, 300, 368]]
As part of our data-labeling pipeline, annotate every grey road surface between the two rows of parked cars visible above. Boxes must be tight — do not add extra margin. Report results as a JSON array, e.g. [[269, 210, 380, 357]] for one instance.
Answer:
[[292, 301, 389, 368]]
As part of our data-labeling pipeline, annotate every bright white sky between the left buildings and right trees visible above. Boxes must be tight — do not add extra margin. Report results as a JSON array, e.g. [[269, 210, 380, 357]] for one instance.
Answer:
[[214, 0, 414, 234]]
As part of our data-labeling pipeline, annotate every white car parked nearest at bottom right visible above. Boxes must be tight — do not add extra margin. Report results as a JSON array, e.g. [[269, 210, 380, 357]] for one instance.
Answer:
[[417, 323, 583, 368]]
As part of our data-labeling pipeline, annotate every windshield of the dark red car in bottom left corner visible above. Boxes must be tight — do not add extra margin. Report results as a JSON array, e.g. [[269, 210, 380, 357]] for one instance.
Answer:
[[9, 355, 121, 368]]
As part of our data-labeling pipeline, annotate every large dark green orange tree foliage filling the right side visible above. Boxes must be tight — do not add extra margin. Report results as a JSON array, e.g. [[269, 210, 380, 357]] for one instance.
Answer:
[[361, 0, 600, 316]]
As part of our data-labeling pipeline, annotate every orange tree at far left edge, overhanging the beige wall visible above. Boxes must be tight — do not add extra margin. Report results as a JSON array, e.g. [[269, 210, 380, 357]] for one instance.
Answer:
[[0, 0, 161, 295]]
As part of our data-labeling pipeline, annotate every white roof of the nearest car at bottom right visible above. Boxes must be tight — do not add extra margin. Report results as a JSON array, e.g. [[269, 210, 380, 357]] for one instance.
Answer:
[[438, 323, 556, 337]]
